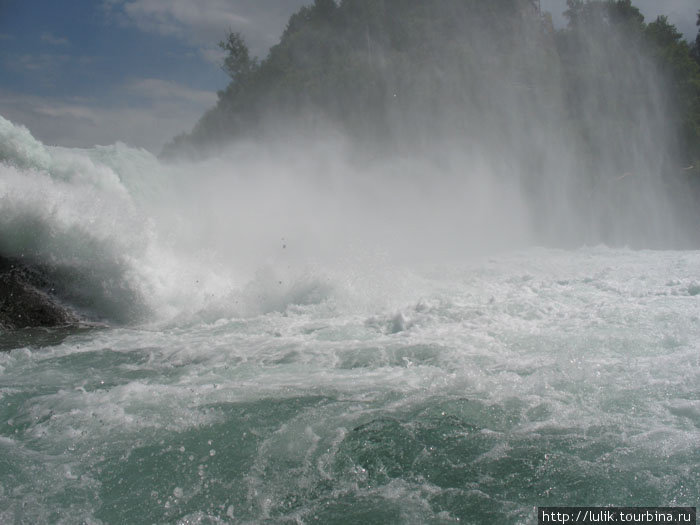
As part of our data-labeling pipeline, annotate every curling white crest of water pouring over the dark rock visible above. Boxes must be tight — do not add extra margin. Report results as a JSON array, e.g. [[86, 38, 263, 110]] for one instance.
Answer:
[[0, 119, 152, 321]]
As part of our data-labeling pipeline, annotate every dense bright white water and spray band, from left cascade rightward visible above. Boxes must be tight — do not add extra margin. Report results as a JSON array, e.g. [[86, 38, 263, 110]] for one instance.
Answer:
[[0, 118, 531, 324]]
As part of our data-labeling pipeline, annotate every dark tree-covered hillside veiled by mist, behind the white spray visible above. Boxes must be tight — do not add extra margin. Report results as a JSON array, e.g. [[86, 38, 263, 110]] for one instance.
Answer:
[[164, 0, 700, 246]]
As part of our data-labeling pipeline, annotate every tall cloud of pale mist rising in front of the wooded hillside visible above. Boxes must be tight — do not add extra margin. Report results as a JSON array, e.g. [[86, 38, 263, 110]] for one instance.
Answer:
[[166, 1, 695, 257]]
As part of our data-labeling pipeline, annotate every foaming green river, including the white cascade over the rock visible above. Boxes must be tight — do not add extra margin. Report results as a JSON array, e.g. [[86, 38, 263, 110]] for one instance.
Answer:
[[0, 116, 700, 524]]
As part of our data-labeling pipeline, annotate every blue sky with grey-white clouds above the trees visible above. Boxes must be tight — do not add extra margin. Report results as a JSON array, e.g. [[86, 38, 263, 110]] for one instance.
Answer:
[[0, 0, 700, 153]]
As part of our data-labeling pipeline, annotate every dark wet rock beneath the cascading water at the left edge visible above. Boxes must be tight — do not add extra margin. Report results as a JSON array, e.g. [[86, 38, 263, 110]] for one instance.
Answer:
[[0, 256, 78, 330]]
